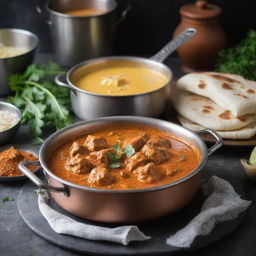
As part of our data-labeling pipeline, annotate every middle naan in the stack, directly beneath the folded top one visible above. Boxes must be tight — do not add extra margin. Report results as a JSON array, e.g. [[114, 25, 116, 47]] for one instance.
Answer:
[[173, 90, 256, 130]]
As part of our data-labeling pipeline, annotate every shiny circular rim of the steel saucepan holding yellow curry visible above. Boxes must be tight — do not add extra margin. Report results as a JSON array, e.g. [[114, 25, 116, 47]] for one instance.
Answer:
[[66, 56, 173, 98]]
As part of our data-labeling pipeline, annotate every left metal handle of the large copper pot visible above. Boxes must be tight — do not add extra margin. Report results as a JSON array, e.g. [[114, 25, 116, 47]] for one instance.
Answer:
[[19, 161, 70, 196]]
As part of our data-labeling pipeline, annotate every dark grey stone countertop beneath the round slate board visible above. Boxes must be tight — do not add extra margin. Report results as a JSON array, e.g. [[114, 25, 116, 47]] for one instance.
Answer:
[[0, 55, 256, 256]]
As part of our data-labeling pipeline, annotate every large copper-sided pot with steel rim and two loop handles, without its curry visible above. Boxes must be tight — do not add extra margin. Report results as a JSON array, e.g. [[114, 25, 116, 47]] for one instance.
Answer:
[[19, 116, 222, 222]]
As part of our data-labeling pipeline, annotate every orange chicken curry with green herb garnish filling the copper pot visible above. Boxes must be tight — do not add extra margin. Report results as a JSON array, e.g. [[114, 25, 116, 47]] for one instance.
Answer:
[[48, 125, 200, 190]]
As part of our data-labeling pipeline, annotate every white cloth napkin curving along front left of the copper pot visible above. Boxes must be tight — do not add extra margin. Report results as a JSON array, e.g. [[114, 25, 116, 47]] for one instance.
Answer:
[[38, 196, 150, 245]]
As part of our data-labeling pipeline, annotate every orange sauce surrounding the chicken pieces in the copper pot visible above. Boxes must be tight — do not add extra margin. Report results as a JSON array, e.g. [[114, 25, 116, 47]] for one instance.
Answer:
[[48, 125, 201, 190]]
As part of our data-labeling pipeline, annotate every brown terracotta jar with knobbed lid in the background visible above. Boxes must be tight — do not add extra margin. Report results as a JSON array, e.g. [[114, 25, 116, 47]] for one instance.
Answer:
[[173, 0, 226, 72]]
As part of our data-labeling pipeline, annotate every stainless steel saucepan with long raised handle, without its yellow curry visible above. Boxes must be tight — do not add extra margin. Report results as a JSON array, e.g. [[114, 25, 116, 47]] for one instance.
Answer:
[[55, 28, 196, 120]]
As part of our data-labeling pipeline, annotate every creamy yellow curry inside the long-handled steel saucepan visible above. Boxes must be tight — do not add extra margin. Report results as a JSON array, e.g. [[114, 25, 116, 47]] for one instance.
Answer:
[[73, 62, 168, 96]]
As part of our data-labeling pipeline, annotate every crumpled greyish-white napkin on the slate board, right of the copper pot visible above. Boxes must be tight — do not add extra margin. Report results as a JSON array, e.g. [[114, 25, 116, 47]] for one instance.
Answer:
[[166, 176, 251, 248]]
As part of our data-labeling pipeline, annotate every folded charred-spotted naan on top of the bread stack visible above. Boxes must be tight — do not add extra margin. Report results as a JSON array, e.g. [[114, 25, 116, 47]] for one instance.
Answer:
[[177, 72, 256, 117]]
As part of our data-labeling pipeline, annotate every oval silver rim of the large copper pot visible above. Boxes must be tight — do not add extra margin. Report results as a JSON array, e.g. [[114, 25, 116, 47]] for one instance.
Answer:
[[39, 116, 208, 194]]
